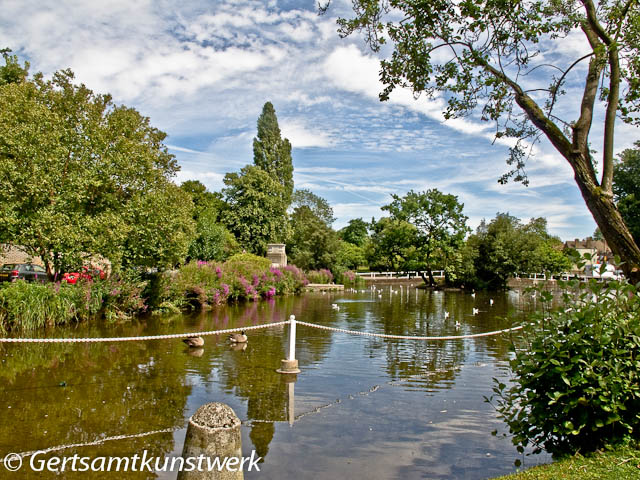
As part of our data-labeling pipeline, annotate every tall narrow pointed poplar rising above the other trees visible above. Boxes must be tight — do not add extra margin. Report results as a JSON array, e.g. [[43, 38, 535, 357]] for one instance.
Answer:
[[253, 102, 293, 206]]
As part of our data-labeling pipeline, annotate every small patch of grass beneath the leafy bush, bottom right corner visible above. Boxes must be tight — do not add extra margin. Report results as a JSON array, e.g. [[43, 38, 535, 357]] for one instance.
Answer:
[[496, 447, 640, 480]]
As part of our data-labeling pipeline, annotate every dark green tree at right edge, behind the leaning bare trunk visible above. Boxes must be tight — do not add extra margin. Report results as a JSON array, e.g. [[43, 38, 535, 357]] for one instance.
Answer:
[[613, 142, 640, 244]]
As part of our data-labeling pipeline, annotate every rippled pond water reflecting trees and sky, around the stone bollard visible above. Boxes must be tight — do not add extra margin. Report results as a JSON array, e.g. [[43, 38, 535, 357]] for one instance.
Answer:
[[0, 286, 549, 479]]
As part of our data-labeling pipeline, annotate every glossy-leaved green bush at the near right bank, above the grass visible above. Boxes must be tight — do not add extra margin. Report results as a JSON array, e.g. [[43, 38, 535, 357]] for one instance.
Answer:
[[489, 280, 640, 455]]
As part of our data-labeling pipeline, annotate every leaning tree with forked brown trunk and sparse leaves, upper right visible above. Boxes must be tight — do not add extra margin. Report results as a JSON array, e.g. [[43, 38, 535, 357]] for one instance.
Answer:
[[336, 0, 640, 282]]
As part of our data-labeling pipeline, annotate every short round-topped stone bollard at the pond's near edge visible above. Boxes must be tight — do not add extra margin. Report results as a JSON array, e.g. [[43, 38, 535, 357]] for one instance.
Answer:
[[178, 402, 244, 480]]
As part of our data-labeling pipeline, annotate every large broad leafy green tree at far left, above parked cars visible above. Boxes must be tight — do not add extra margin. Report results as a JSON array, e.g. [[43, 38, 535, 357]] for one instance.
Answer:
[[0, 66, 192, 276]]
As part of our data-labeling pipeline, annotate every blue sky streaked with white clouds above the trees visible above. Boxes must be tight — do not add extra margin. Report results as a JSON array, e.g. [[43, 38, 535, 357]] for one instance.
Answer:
[[0, 0, 640, 240]]
